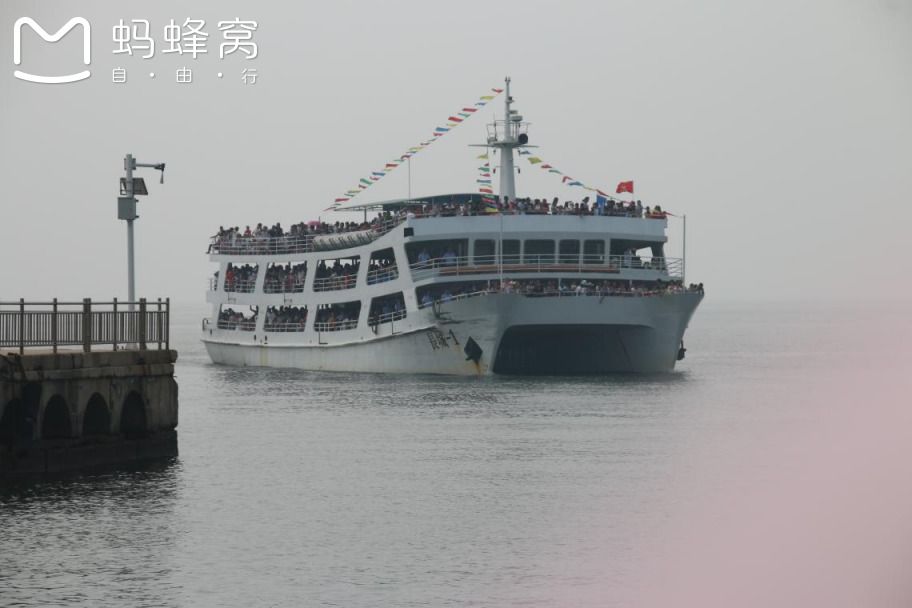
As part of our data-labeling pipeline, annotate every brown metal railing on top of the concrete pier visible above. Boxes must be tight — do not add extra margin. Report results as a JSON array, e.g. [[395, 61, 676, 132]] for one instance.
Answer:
[[0, 298, 171, 353]]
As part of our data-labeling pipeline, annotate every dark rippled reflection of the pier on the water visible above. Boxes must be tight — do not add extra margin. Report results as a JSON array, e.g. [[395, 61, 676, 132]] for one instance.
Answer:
[[0, 459, 181, 606]]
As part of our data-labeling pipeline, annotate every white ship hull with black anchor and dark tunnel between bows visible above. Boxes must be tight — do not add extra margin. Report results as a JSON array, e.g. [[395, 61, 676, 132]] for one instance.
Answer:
[[203, 292, 702, 376]]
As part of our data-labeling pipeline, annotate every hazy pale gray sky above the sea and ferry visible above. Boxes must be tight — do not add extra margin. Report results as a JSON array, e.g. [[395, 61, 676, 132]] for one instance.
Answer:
[[0, 0, 912, 305]]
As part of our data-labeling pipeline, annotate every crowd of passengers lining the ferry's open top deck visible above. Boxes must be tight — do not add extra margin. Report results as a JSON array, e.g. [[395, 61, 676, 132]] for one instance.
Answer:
[[209, 196, 667, 253]]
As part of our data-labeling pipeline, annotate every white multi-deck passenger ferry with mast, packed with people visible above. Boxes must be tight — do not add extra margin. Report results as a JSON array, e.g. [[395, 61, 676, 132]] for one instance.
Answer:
[[202, 79, 703, 375]]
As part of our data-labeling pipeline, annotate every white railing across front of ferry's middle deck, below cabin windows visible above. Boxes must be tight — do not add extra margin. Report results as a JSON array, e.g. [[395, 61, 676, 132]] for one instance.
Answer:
[[409, 255, 684, 281]]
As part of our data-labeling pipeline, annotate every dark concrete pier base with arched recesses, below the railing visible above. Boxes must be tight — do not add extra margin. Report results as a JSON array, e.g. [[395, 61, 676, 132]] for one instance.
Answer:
[[0, 349, 178, 478]]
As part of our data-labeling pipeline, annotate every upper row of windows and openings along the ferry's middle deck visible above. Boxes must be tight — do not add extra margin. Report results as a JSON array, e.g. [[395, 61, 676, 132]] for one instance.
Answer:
[[210, 239, 662, 293]]
